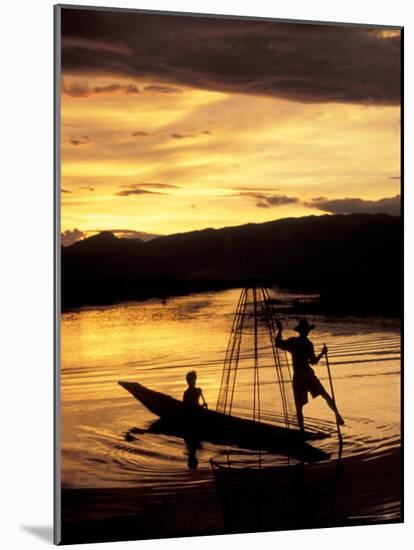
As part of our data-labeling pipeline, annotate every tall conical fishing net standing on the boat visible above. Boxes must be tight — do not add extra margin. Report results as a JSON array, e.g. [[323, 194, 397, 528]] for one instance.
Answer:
[[217, 287, 298, 428]]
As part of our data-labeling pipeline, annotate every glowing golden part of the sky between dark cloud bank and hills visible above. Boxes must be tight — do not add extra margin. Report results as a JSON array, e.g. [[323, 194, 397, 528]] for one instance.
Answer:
[[61, 8, 400, 242]]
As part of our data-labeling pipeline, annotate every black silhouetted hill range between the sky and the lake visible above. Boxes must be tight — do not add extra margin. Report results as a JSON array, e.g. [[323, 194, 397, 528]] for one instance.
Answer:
[[62, 214, 403, 314]]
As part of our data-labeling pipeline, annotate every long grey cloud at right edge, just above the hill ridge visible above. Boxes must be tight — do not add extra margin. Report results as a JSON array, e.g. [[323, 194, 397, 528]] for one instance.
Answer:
[[304, 195, 401, 216]]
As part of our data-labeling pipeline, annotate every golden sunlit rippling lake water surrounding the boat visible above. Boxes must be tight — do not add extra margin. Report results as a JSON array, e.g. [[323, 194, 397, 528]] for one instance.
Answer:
[[61, 289, 400, 536]]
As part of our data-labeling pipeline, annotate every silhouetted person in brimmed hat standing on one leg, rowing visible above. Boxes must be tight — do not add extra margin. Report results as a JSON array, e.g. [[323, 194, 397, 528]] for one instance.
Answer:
[[276, 319, 345, 431]]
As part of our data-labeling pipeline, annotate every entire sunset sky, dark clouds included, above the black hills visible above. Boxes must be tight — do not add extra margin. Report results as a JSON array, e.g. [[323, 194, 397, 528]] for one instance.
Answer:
[[61, 8, 400, 244]]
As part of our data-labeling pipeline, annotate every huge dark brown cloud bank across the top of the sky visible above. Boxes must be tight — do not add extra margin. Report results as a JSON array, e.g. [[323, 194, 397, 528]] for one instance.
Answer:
[[62, 7, 401, 105]]
